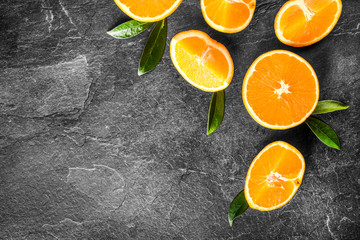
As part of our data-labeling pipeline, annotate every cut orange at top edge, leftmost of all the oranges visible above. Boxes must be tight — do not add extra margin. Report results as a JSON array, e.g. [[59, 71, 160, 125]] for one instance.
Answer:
[[115, 0, 182, 22]]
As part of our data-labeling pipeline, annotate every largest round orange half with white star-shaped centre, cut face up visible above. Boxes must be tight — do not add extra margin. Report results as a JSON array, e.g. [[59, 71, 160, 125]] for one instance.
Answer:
[[242, 50, 319, 129]]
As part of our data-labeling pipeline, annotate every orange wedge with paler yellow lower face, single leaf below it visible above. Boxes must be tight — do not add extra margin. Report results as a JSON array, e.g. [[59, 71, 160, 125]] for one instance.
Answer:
[[170, 30, 234, 92]]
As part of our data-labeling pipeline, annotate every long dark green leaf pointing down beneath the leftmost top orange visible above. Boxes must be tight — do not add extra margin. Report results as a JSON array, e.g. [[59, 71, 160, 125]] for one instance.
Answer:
[[138, 19, 167, 76]]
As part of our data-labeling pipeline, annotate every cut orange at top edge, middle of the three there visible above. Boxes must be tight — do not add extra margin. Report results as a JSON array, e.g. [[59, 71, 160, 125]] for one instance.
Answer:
[[201, 0, 256, 33]]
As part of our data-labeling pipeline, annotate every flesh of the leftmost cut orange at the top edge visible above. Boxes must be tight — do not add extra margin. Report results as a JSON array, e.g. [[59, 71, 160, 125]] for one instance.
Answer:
[[120, 0, 176, 18]]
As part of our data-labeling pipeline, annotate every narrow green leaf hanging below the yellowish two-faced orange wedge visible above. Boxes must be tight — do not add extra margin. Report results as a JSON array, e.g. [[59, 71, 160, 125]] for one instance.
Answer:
[[207, 90, 225, 135]]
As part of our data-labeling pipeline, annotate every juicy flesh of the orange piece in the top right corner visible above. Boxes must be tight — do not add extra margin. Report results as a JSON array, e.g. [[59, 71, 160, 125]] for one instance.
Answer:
[[280, 0, 339, 44]]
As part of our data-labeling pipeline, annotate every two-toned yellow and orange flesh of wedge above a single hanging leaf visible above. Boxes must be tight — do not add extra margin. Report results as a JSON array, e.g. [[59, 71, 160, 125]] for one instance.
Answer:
[[175, 34, 229, 88]]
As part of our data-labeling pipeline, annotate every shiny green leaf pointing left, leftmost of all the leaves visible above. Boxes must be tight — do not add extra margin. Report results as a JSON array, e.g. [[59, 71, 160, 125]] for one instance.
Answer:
[[107, 20, 154, 39]]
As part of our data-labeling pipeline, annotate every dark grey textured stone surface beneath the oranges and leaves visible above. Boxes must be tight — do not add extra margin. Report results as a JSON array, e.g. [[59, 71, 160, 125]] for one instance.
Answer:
[[0, 0, 360, 240]]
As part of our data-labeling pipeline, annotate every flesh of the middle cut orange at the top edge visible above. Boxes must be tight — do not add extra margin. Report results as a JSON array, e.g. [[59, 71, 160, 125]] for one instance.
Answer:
[[204, 0, 255, 29]]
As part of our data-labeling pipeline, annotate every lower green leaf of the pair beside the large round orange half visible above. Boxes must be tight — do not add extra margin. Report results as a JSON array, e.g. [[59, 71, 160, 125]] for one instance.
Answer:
[[305, 117, 340, 150]]
